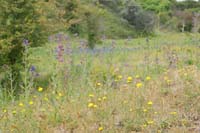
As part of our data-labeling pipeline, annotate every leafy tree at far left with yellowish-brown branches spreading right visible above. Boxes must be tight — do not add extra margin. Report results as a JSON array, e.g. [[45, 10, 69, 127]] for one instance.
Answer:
[[0, 0, 79, 93]]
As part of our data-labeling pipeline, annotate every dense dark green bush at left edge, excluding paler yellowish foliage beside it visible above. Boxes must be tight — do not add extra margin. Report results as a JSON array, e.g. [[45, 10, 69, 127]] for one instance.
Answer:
[[0, 0, 47, 92]]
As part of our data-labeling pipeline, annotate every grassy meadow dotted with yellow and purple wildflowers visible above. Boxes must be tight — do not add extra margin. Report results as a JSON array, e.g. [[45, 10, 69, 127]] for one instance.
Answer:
[[0, 34, 200, 133]]
